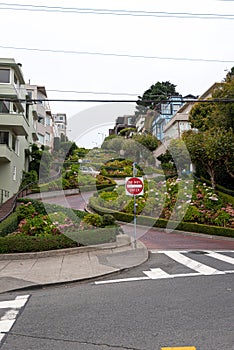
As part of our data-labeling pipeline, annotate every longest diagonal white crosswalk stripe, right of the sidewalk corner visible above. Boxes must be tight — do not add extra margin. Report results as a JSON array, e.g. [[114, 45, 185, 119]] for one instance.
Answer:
[[164, 251, 224, 275]]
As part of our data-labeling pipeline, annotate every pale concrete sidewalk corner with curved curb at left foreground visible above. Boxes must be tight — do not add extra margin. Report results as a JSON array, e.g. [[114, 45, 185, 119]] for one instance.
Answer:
[[0, 235, 148, 293]]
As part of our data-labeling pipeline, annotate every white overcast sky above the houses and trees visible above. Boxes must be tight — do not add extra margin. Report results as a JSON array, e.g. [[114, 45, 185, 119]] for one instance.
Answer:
[[0, 0, 234, 147]]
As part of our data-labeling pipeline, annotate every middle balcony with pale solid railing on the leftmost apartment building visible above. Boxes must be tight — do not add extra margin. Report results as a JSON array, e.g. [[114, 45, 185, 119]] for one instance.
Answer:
[[0, 113, 29, 136]]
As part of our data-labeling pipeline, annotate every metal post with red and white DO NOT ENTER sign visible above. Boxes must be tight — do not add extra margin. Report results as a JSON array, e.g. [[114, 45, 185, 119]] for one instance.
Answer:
[[125, 163, 144, 248]]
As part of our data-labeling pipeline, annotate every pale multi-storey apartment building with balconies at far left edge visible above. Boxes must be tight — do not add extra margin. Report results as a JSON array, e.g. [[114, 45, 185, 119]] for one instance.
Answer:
[[0, 58, 37, 204]]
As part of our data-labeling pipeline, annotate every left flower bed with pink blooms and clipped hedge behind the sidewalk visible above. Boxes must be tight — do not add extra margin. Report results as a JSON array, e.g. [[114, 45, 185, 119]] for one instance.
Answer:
[[0, 199, 119, 253]]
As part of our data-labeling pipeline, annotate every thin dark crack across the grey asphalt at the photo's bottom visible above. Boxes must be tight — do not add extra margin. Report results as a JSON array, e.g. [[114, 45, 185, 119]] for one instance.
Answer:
[[9, 332, 144, 350]]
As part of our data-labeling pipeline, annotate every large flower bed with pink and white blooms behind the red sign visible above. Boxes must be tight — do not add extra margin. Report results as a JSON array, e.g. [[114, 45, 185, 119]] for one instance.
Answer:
[[90, 178, 234, 228]]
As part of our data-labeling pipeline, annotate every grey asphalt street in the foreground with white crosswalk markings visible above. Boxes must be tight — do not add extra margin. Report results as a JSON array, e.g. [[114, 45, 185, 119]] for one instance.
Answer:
[[0, 251, 234, 350]]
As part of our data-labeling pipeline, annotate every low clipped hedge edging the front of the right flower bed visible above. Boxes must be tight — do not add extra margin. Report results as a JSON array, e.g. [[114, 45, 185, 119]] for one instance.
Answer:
[[89, 199, 234, 238]]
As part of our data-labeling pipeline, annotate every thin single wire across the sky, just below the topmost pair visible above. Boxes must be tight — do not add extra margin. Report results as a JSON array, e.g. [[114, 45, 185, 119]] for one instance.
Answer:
[[0, 45, 234, 63]]
